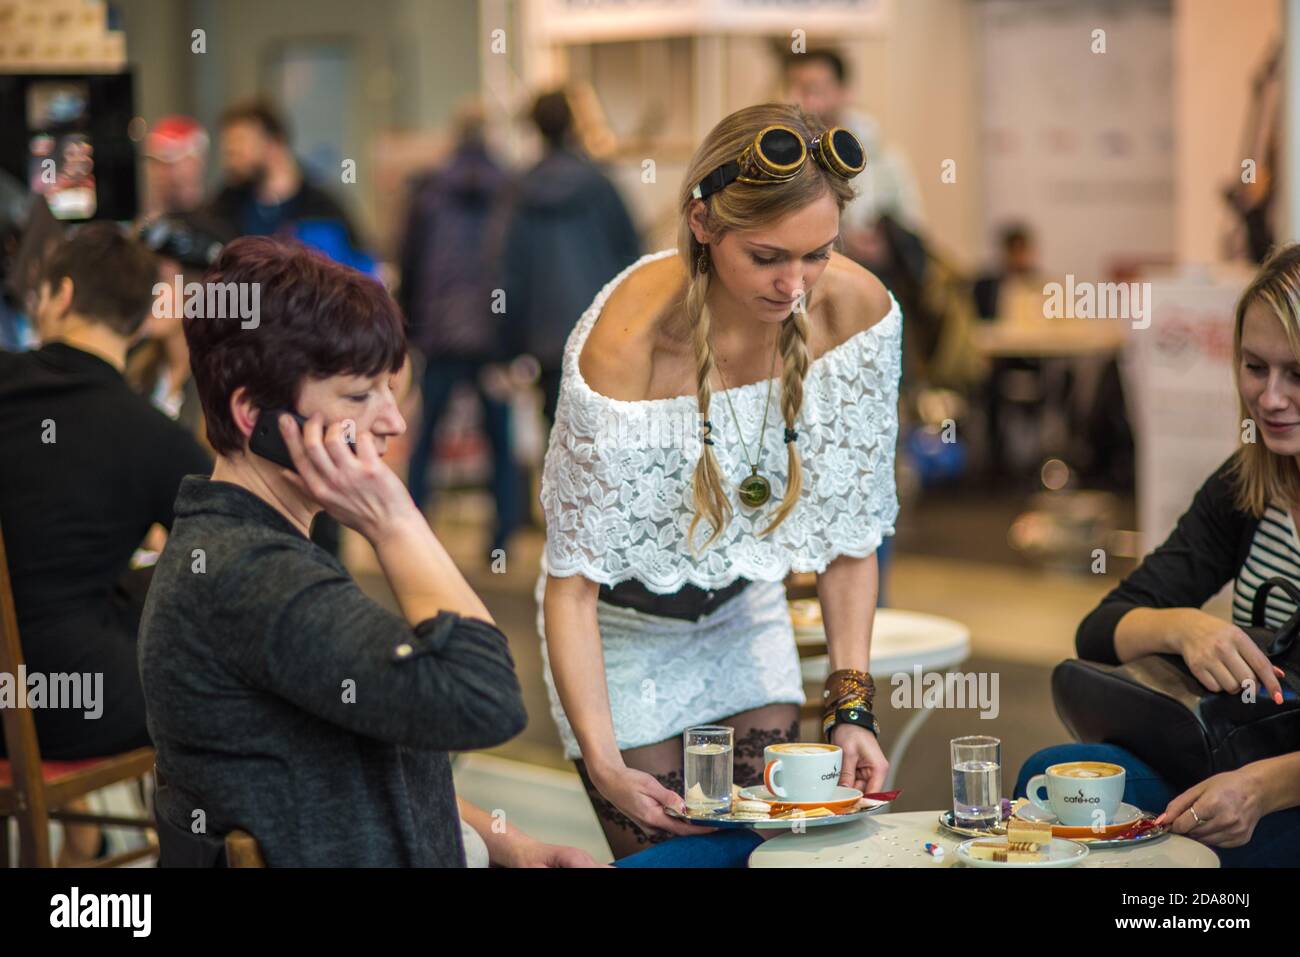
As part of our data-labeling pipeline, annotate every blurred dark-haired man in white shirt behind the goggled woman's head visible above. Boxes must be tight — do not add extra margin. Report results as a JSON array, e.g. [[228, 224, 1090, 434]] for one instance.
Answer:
[[785, 49, 923, 268]]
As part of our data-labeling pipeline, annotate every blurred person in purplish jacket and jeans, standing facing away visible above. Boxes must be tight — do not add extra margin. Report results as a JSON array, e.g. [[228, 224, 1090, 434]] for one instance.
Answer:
[[398, 104, 523, 554]]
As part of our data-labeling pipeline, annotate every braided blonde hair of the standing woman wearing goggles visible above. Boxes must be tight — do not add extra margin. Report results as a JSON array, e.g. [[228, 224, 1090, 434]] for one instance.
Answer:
[[677, 103, 855, 551]]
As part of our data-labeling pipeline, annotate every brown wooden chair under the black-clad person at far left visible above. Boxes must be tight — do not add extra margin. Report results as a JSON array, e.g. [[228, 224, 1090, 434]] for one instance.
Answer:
[[0, 531, 157, 867]]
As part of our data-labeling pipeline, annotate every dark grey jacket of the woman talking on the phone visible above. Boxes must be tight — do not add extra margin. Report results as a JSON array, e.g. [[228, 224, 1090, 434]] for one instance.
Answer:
[[139, 476, 527, 867]]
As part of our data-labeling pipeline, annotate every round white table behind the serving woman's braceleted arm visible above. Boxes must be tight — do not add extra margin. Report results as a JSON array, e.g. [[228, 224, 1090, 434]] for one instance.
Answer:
[[794, 609, 971, 791]]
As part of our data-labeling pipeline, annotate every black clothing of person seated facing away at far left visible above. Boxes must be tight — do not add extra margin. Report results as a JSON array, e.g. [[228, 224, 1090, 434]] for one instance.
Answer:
[[0, 342, 211, 761]]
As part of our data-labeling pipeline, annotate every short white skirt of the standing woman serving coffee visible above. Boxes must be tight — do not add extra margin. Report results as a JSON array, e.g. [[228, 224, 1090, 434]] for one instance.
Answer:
[[536, 572, 805, 761]]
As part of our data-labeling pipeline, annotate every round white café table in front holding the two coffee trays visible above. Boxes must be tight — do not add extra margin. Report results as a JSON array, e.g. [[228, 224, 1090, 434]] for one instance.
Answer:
[[749, 810, 1219, 867]]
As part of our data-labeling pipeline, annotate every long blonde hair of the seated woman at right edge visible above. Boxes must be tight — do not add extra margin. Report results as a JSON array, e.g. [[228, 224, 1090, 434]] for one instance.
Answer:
[[1230, 243, 1300, 516]]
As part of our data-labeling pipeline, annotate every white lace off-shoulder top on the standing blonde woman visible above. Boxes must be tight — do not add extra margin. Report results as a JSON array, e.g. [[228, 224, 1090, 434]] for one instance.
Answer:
[[541, 248, 902, 594]]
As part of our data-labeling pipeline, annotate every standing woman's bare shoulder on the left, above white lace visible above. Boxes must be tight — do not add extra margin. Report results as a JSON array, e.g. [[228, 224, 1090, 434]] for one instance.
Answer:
[[579, 256, 683, 402]]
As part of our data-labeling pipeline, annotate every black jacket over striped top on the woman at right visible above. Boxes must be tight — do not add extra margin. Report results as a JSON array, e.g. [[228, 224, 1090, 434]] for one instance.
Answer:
[[1075, 458, 1260, 664]]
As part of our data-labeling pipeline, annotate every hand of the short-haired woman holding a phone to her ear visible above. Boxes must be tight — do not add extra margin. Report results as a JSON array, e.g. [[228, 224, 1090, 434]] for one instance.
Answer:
[[280, 413, 419, 544]]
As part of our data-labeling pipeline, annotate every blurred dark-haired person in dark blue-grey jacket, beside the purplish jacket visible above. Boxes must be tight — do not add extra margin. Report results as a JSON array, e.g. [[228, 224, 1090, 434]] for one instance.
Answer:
[[501, 91, 641, 421]]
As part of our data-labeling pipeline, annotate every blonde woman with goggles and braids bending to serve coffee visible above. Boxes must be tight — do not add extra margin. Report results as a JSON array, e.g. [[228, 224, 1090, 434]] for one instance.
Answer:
[[537, 104, 902, 857]]
